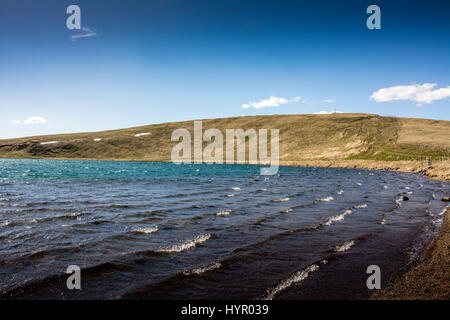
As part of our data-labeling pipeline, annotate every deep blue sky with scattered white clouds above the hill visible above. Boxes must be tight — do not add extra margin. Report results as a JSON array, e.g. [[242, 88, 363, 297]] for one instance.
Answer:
[[0, 0, 450, 138]]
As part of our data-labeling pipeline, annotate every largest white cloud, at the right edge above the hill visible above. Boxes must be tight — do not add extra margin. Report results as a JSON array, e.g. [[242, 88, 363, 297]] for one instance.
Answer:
[[370, 83, 450, 106]]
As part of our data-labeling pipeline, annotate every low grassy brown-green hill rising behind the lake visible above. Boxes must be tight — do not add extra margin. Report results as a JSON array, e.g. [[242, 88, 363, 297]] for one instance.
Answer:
[[0, 114, 450, 163]]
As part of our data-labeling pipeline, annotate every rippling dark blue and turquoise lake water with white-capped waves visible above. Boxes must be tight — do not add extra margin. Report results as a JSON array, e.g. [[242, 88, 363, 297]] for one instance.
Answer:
[[0, 160, 450, 299]]
